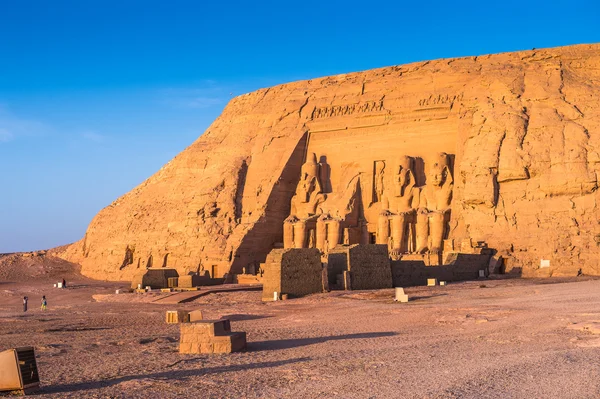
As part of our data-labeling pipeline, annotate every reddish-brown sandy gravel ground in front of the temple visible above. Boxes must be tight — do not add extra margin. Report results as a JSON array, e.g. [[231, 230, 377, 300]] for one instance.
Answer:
[[0, 262, 600, 399]]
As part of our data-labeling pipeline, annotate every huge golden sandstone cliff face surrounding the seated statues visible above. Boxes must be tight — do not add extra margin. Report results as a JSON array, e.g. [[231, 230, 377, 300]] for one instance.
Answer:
[[62, 45, 600, 280]]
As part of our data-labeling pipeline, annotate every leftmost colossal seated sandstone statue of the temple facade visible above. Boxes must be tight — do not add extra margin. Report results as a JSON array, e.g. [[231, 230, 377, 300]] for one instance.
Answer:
[[283, 153, 326, 248]]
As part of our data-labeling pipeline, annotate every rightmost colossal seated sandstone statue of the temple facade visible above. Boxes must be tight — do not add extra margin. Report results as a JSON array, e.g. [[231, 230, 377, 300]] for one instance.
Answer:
[[416, 152, 454, 254]]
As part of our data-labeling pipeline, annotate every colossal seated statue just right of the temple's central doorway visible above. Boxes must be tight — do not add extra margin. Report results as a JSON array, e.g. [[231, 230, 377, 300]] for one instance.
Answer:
[[376, 156, 419, 256]]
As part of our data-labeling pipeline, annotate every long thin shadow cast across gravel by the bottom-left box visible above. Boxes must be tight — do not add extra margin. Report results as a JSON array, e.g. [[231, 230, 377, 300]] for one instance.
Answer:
[[36, 357, 310, 394]]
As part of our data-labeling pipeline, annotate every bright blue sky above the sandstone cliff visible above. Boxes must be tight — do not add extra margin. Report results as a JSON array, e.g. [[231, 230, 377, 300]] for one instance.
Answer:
[[0, 0, 600, 252]]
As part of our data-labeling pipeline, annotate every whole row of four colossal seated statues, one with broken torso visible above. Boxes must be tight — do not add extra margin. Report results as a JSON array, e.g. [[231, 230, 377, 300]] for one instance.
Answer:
[[284, 153, 453, 253]]
